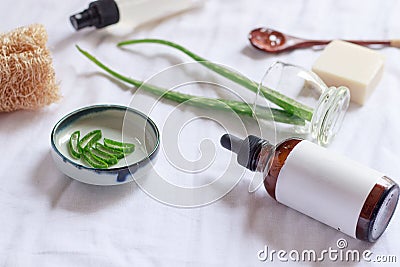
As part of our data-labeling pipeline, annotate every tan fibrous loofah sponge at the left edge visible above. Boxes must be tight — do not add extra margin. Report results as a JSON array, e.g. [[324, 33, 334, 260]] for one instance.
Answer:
[[0, 24, 60, 112]]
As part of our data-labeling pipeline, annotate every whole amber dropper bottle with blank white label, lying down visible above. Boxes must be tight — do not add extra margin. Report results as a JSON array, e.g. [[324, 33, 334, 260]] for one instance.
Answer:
[[221, 134, 399, 242]]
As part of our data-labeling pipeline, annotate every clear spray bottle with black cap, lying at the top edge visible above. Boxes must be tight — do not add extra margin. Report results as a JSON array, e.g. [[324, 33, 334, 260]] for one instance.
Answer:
[[70, 0, 202, 34]]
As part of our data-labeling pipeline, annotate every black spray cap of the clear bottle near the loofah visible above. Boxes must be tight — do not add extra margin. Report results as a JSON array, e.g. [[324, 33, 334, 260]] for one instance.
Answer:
[[69, 0, 119, 30]]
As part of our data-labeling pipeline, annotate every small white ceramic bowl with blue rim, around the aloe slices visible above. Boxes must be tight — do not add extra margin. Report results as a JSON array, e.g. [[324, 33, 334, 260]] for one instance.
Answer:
[[51, 105, 160, 185]]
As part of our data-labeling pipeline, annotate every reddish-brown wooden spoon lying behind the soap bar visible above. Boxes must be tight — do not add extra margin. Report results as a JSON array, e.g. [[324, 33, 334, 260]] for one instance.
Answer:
[[249, 28, 400, 53]]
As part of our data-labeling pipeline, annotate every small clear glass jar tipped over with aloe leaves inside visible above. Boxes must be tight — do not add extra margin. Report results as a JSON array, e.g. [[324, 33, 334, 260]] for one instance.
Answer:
[[255, 61, 350, 146]]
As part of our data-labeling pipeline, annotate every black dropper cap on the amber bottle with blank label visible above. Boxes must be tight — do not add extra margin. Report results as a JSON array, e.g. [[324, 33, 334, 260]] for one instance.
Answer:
[[220, 134, 270, 171]]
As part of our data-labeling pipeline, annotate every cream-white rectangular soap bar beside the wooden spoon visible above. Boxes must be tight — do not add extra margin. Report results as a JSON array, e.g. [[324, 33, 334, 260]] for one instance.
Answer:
[[312, 40, 384, 105]]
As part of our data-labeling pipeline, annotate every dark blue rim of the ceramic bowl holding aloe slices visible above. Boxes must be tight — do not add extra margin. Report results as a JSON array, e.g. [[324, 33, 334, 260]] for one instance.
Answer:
[[50, 104, 160, 173]]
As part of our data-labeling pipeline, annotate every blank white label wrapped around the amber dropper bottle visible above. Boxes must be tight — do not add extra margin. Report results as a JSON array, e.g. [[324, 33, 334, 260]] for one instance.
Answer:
[[275, 141, 384, 238]]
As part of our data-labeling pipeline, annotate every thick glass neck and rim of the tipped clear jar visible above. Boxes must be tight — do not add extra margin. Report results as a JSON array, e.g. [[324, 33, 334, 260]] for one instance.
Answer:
[[310, 86, 350, 145]]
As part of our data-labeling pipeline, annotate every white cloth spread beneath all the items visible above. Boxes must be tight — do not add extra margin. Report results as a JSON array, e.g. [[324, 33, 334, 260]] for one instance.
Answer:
[[0, 0, 400, 267]]
